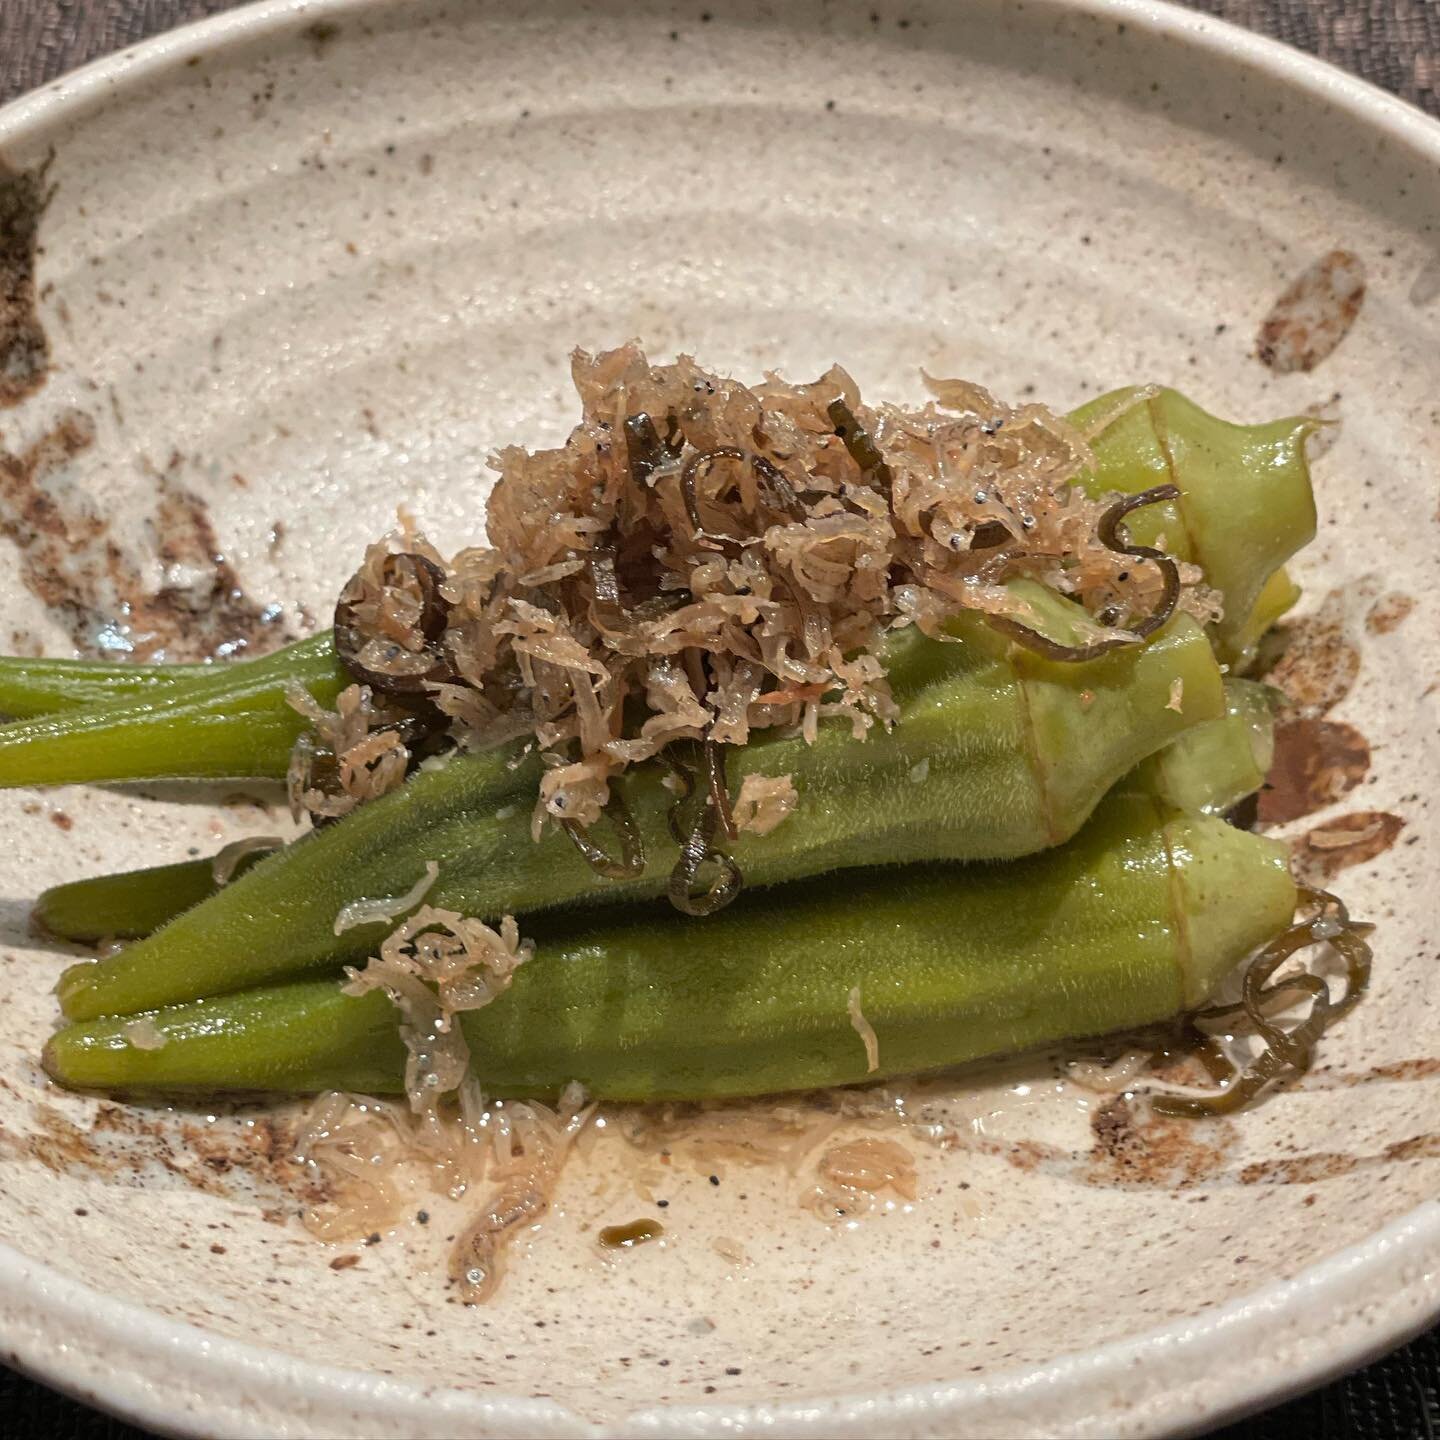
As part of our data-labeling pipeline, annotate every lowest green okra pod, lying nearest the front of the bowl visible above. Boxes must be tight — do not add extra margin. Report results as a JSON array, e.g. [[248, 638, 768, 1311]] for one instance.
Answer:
[[45, 789, 1296, 1100]]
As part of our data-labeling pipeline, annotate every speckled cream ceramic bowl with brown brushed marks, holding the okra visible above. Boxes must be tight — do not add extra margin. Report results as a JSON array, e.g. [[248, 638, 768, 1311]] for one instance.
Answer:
[[0, 0, 1440, 1437]]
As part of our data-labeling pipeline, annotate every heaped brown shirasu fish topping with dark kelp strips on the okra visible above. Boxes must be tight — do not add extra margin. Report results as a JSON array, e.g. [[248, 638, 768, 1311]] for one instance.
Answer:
[[291, 344, 1218, 913]]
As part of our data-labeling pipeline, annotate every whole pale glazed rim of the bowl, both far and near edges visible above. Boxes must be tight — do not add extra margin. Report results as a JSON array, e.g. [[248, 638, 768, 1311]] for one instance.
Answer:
[[0, 0, 1440, 1440]]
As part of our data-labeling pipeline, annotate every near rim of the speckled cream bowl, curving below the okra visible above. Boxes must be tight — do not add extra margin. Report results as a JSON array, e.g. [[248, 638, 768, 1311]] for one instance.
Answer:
[[11, 1201, 1440, 1440]]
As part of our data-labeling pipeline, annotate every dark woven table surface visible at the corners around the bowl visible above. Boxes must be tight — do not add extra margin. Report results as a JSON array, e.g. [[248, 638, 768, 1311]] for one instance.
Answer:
[[0, 0, 1440, 1440]]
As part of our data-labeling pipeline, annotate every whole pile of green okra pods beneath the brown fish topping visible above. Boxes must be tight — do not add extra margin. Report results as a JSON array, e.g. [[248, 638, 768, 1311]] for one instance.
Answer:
[[0, 392, 1315, 1100]]
